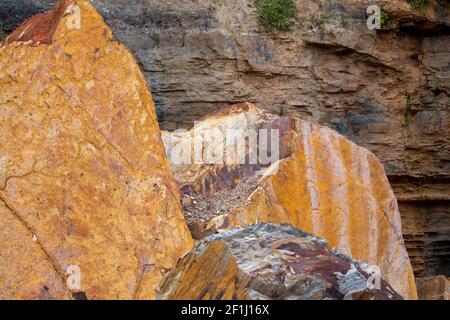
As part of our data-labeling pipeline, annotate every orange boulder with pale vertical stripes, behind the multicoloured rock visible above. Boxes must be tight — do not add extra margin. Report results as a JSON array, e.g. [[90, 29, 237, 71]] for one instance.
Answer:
[[163, 103, 416, 299]]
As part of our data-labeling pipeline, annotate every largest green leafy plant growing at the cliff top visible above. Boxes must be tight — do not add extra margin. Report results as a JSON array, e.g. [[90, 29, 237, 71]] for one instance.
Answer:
[[255, 0, 297, 31]]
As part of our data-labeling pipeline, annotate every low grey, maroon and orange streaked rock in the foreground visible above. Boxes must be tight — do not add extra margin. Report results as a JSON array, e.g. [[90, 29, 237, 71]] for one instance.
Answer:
[[158, 223, 402, 300]]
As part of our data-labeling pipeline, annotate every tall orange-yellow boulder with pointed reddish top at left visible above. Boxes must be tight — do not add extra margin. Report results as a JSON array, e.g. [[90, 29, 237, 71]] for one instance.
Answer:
[[0, 0, 192, 299]]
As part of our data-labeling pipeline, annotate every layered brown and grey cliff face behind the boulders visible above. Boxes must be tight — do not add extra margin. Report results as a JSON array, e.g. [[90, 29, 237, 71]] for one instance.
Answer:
[[0, 0, 450, 284]]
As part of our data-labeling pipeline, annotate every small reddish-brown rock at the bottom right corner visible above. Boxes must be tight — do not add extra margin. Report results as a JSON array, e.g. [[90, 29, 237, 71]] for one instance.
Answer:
[[417, 276, 450, 300]]
